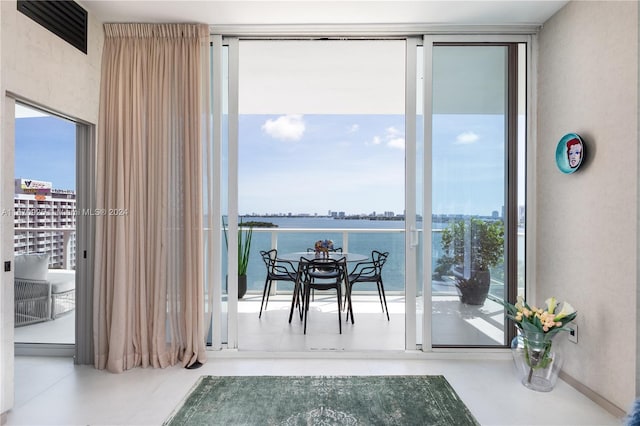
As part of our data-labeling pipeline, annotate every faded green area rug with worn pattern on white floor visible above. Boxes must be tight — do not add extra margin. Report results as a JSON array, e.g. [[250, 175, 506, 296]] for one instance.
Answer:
[[164, 376, 479, 426]]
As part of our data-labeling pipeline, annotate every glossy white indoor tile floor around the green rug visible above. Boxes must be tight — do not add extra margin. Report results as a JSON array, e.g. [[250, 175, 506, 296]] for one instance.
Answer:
[[5, 352, 622, 426]]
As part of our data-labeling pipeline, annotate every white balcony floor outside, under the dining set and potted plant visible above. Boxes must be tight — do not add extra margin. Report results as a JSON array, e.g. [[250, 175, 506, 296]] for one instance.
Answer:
[[14, 292, 504, 351]]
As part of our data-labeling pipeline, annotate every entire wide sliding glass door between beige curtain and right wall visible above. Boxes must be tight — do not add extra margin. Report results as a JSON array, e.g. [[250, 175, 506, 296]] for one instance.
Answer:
[[210, 36, 529, 350]]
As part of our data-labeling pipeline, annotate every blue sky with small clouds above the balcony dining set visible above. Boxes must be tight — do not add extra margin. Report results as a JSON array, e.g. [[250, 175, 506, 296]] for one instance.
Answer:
[[239, 115, 404, 214]]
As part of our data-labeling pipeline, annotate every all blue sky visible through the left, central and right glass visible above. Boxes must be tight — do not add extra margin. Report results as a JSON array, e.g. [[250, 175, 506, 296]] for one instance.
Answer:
[[15, 114, 504, 215]]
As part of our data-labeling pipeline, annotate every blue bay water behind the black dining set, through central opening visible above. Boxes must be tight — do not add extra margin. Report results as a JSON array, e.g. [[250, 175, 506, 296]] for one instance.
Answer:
[[223, 216, 440, 292]]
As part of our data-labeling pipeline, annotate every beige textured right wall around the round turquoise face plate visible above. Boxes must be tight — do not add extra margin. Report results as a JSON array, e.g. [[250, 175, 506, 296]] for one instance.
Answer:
[[534, 1, 638, 411]]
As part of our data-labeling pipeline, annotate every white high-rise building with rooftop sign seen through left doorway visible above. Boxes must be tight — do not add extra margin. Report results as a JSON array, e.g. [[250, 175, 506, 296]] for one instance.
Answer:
[[13, 178, 76, 269]]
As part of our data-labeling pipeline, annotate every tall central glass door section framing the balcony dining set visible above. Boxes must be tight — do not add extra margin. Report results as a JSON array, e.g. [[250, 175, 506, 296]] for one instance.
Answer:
[[229, 39, 408, 351]]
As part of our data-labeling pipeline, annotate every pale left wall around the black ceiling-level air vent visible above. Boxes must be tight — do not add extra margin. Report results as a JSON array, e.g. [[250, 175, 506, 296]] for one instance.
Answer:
[[0, 0, 103, 413]]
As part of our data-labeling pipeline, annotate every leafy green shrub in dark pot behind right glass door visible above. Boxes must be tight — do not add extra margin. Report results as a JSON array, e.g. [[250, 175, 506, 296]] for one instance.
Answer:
[[434, 218, 504, 305]]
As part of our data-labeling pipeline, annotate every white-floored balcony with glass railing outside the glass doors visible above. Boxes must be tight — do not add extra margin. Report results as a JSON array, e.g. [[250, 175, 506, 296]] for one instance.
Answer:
[[15, 228, 516, 352]]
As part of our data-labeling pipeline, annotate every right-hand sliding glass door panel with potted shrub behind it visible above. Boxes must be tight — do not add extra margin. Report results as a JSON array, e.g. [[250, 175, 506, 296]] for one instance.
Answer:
[[425, 38, 525, 347]]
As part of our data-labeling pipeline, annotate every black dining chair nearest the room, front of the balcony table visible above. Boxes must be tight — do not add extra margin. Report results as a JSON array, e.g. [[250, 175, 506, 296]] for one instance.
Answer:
[[296, 257, 347, 334]]
